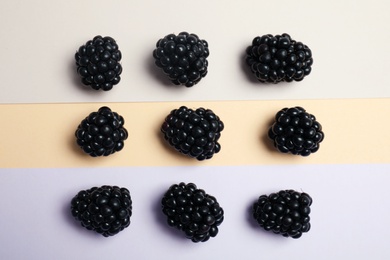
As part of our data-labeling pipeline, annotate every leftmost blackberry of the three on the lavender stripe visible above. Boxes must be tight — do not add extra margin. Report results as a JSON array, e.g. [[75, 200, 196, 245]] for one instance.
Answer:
[[71, 185, 132, 237]]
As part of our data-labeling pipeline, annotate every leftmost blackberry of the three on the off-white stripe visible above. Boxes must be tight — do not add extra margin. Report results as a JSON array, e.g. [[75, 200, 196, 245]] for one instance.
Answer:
[[75, 35, 122, 91]]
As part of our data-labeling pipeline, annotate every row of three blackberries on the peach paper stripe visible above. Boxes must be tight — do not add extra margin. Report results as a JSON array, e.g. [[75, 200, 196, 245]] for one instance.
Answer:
[[75, 106, 324, 160]]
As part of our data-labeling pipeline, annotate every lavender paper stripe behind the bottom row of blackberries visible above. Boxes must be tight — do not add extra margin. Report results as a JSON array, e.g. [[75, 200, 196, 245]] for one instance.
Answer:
[[0, 164, 390, 260]]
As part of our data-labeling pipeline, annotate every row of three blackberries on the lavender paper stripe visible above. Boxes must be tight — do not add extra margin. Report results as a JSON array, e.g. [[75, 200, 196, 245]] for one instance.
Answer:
[[71, 182, 312, 242]]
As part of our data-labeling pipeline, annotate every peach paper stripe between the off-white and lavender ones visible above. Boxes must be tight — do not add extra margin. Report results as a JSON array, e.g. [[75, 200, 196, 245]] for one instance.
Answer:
[[0, 99, 390, 168]]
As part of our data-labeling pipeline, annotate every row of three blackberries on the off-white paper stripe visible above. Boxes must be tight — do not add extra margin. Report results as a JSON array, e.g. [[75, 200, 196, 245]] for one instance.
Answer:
[[75, 32, 313, 91]]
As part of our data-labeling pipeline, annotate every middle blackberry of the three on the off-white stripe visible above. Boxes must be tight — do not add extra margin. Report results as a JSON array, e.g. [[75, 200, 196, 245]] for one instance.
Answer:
[[153, 32, 210, 87]]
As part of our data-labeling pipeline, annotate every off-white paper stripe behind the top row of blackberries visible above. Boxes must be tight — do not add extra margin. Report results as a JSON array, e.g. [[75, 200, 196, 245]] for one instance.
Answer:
[[0, 0, 390, 103]]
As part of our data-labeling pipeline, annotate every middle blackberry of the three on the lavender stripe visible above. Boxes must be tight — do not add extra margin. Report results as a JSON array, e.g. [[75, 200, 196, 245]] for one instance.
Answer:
[[161, 182, 224, 243]]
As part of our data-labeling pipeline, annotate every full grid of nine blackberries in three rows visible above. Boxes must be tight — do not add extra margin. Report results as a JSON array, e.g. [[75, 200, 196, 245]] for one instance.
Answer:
[[71, 32, 324, 242]]
